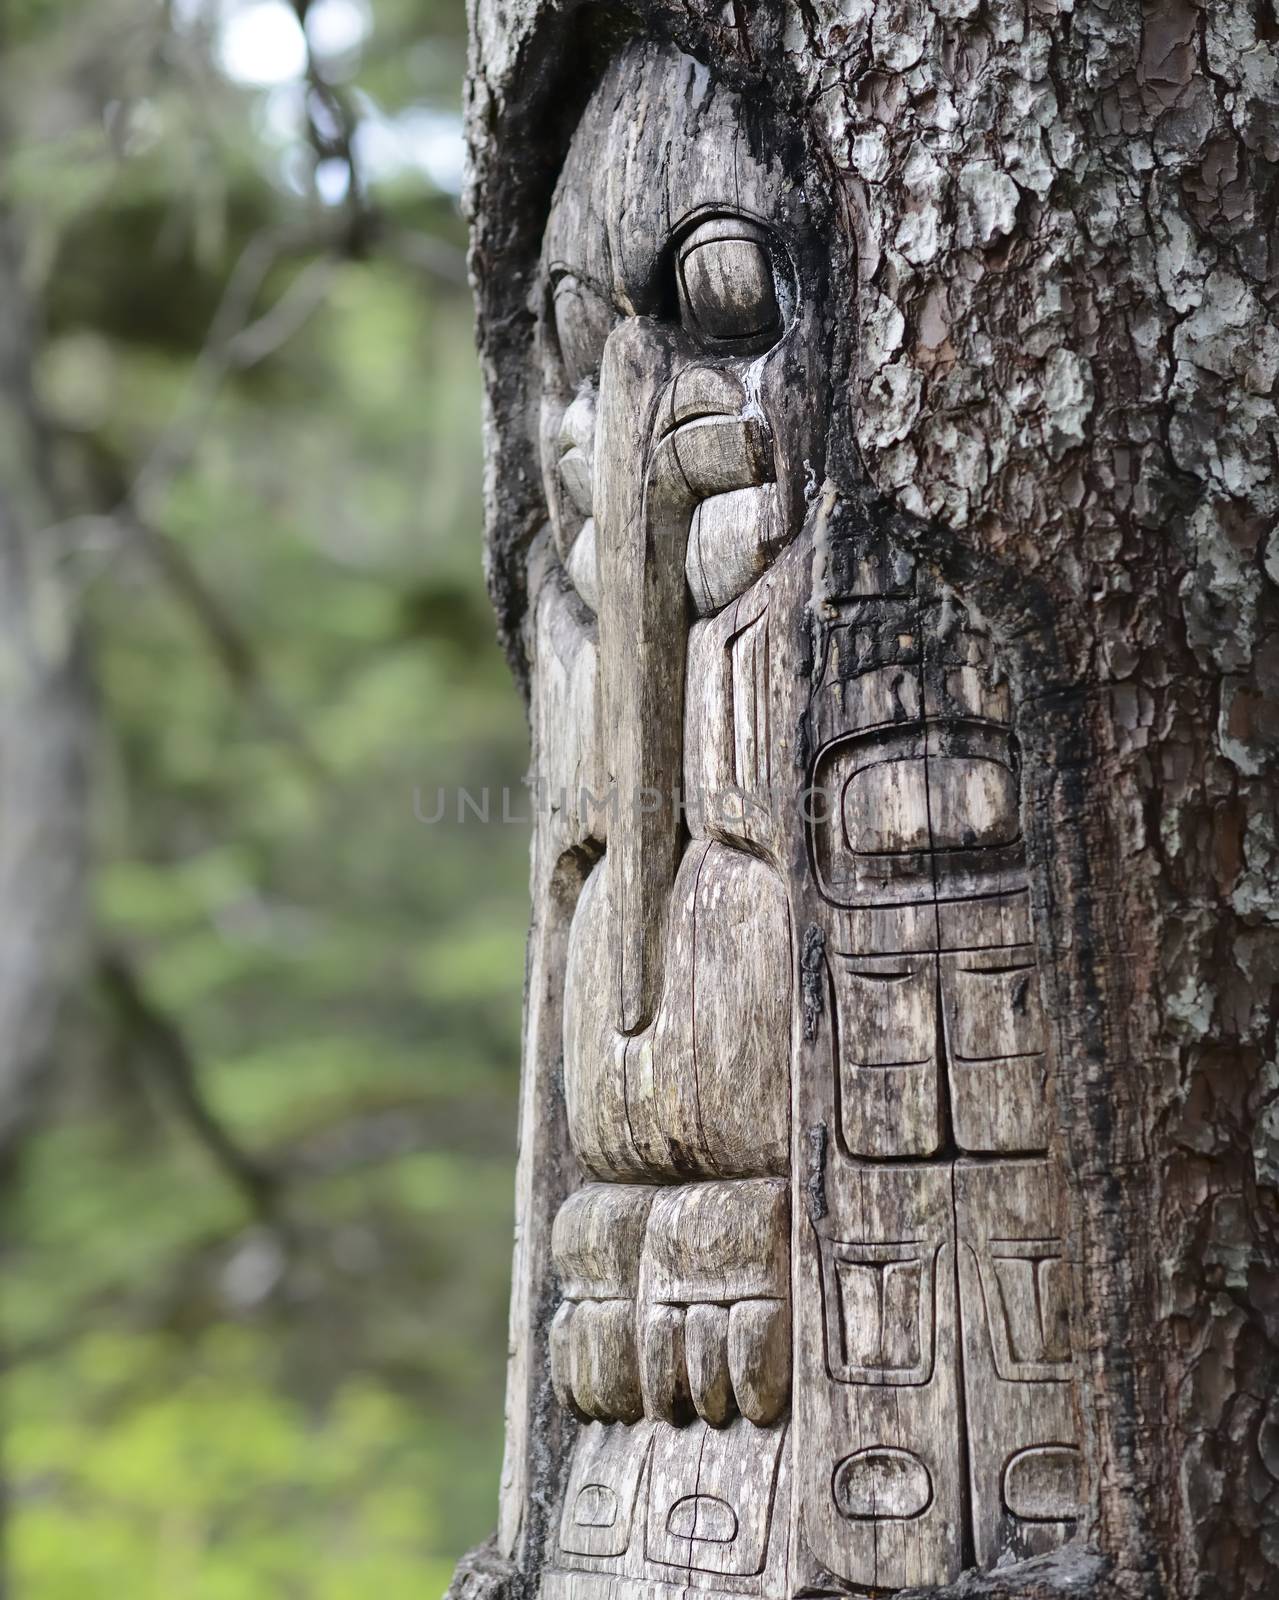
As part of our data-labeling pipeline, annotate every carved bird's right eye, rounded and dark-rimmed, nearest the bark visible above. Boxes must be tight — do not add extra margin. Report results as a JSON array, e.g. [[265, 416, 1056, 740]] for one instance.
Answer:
[[679, 216, 781, 342]]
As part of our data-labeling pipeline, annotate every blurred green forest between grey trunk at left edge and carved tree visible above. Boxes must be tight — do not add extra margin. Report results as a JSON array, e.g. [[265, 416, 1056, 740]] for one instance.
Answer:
[[0, 0, 528, 1600]]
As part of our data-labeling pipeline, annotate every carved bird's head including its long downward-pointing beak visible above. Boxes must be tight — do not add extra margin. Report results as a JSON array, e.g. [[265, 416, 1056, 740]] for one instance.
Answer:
[[539, 48, 824, 1034]]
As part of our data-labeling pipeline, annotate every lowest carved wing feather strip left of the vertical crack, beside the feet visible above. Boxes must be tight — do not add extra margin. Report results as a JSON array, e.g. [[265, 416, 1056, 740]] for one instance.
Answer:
[[794, 1160, 964, 1589]]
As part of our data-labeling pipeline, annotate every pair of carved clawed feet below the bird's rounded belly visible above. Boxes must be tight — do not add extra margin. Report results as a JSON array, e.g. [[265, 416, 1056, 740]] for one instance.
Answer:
[[551, 1179, 791, 1427]]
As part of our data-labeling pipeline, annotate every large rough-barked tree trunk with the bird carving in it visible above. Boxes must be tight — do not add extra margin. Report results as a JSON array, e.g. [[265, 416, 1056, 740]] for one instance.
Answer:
[[455, 0, 1279, 1600]]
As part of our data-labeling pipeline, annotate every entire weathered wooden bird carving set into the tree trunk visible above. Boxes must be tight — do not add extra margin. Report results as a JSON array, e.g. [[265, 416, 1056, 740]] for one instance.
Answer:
[[486, 45, 1081, 1597]]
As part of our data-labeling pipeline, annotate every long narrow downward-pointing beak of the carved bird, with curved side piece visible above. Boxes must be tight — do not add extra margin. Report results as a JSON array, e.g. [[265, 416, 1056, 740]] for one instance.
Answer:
[[594, 318, 773, 1034]]
